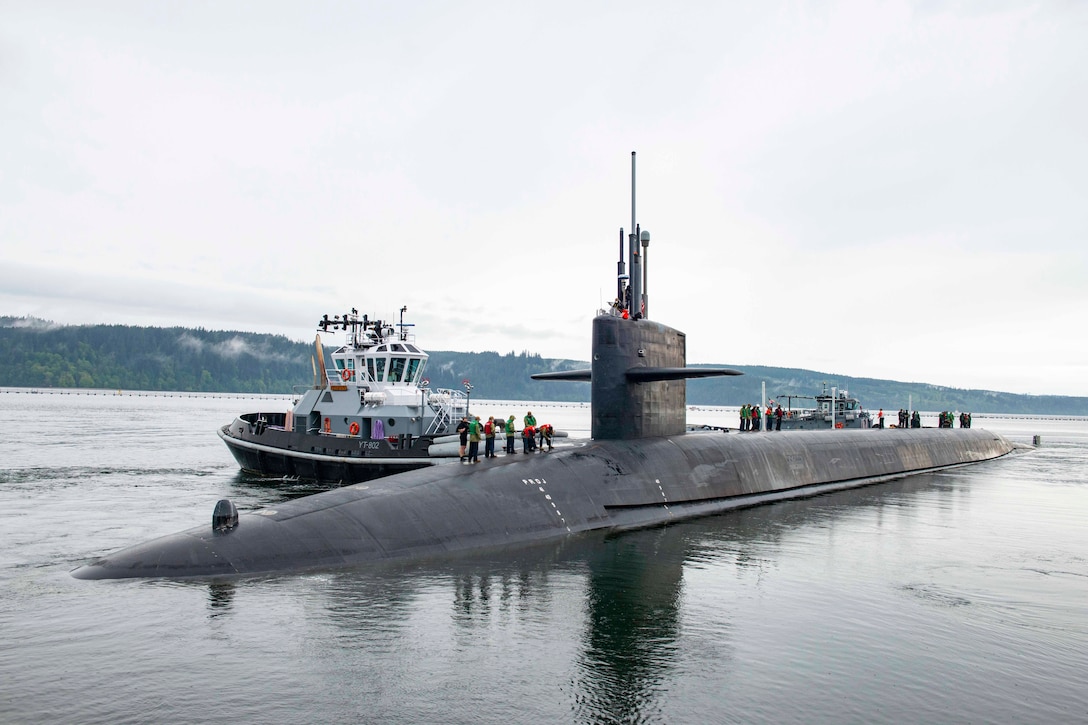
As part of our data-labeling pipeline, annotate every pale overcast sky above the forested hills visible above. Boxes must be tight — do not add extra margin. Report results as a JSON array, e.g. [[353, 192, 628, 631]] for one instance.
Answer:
[[0, 0, 1088, 395]]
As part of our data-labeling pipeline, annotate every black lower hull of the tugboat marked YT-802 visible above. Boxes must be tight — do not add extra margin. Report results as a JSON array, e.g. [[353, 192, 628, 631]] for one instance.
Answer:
[[219, 416, 450, 486]]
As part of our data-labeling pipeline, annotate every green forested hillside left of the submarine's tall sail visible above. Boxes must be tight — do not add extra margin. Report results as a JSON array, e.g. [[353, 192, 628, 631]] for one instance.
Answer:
[[0, 317, 590, 401]]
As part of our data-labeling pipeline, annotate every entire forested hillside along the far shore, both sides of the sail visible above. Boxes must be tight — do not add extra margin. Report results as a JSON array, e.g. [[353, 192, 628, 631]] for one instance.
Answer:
[[6, 317, 1088, 415]]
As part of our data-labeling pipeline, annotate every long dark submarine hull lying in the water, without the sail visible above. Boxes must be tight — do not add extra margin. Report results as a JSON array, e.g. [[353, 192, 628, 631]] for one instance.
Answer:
[[73, 429, 1013, 579]]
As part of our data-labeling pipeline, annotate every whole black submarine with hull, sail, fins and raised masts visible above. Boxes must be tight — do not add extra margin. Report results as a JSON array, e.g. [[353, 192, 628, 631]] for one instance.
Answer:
[[72, 152, 1013, 579]]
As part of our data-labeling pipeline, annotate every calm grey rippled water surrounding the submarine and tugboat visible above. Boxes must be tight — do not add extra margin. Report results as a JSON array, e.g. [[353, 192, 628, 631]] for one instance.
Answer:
[[0, 391, 1088, 723]]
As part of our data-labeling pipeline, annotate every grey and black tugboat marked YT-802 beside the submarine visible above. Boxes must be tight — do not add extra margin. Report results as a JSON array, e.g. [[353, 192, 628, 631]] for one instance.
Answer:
[[219, 307, 468, 484]]
